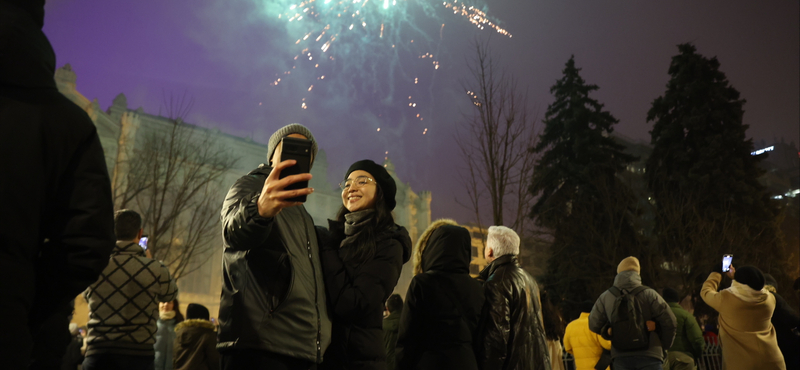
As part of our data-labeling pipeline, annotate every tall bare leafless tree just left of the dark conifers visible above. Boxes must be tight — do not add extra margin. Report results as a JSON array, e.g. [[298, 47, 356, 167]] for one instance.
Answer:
[[456, 38, 536, 234]]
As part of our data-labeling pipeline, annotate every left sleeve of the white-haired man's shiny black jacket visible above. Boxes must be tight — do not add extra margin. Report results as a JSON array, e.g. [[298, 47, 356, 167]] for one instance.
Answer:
[[478, 281, 511, 370]]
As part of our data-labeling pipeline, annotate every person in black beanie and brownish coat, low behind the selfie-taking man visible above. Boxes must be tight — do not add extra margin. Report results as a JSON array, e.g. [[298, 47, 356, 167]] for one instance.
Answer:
[[173, 303, 219, 370]]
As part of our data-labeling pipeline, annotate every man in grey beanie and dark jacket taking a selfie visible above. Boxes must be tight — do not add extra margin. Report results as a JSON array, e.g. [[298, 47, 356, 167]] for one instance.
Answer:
[[217, 123, 331, 370]]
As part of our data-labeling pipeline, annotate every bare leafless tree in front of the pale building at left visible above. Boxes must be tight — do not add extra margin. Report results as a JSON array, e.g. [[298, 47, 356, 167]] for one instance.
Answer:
[[113, 96, 235, 279]]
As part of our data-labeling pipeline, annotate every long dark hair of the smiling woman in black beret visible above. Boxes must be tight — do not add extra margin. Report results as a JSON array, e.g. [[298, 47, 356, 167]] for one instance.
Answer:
[[336, 181, 394, 265]]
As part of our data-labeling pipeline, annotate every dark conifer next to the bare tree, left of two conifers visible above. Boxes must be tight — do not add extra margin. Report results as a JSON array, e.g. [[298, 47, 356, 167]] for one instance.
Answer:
[[530, 56, 639, 312]]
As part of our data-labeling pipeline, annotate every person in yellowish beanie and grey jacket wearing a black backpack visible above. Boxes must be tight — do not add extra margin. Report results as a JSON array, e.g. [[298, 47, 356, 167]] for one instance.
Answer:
[[589, 256, 677, 370]]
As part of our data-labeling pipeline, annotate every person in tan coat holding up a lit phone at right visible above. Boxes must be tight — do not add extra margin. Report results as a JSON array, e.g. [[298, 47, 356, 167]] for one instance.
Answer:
[[700, 264, 796, 370]]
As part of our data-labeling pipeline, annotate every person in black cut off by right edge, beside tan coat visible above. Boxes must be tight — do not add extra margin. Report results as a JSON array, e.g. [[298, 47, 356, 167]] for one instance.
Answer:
[[764, 274, 800, 369]]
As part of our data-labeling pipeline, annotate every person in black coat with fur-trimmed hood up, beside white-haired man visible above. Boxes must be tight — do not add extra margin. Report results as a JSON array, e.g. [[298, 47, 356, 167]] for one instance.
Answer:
[[396, 222, 484, 370]]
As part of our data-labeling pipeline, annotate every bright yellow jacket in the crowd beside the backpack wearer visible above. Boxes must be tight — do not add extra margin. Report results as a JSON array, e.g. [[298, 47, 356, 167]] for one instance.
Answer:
[[564, 312, 611, 370]]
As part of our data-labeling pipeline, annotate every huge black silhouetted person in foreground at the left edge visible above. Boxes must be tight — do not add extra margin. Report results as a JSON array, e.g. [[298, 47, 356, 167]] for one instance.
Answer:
[[0, 0, 115, 369]]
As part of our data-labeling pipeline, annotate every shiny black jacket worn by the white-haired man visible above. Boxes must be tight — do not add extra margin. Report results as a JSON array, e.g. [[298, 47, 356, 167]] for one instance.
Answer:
[[476, 255, 550, 370]]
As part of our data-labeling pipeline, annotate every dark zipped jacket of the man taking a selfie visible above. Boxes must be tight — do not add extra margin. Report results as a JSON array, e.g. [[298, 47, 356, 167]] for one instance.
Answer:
[[217, 165, 331, 363]]
